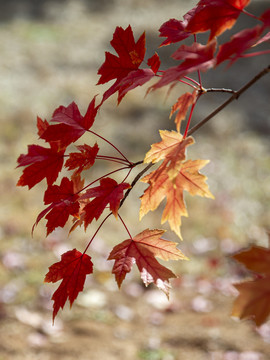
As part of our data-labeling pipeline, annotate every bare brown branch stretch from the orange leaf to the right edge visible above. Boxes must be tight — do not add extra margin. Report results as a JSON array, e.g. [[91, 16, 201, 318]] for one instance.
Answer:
[[187, 65, 270, 136]]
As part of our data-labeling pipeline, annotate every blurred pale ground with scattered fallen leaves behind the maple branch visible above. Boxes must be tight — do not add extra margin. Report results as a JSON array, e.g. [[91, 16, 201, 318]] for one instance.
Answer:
[[0, 0, 270, 360]]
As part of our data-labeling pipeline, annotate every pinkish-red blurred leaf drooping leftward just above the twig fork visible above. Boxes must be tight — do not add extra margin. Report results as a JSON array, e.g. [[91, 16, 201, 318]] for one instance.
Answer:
[[151, 40, 216, 92]]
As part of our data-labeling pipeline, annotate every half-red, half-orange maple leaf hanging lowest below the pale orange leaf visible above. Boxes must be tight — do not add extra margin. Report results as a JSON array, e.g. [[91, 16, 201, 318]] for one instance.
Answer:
[[108, 229, 188, 296]]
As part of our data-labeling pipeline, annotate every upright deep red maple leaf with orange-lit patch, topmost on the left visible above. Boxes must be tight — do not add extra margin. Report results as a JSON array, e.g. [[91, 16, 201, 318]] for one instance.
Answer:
[[98, 25, 145, 102]]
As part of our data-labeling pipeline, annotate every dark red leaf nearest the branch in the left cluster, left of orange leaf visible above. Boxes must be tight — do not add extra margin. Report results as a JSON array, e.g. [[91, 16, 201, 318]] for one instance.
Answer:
[[81, 178, 130, 229]]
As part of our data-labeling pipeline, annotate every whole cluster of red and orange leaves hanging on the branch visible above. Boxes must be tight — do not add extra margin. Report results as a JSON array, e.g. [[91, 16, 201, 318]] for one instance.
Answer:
[[17, 0, 270, 318]]
